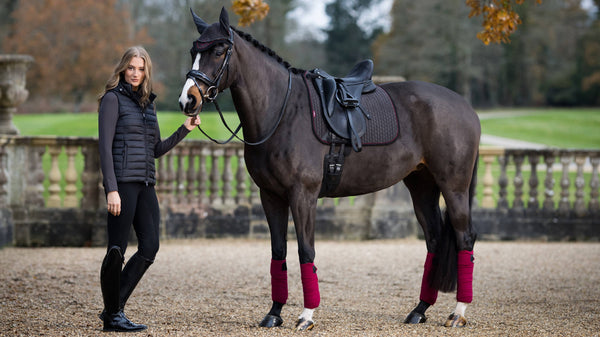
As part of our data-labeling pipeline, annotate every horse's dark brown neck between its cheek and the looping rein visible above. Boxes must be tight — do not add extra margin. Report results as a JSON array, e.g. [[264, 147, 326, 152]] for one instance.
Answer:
[[231, 41, 288, 141]]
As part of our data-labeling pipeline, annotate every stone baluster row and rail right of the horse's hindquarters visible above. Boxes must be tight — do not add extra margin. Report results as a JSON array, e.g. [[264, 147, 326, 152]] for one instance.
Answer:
[[480, 148, 600, 216]]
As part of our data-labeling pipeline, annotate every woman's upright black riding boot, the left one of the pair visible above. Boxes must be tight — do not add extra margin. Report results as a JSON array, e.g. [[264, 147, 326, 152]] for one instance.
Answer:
[[100, 246, 147, 331]]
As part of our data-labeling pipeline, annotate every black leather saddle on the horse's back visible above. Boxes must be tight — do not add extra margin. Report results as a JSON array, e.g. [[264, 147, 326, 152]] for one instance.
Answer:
[[309, 60, 377, 152]]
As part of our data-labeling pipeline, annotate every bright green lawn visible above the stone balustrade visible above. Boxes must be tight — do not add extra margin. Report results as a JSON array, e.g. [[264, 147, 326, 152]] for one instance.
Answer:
[[13, 108, 600, 149]]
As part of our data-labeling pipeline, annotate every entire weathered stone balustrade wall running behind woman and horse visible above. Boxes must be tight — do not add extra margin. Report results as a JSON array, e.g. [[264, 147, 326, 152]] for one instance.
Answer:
[[0, 136, 600, 246]]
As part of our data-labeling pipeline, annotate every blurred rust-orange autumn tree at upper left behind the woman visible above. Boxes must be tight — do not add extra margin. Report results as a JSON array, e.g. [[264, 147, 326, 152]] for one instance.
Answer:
[[3, 0, 151, 111]]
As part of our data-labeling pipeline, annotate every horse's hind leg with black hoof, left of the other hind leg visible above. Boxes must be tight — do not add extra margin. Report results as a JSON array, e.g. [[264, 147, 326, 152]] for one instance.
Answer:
[[404, 167, 442, 324]]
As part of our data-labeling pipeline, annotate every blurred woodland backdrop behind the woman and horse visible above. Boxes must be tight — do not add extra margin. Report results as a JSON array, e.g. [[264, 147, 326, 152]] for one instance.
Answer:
[[0, 0, 600, 113]]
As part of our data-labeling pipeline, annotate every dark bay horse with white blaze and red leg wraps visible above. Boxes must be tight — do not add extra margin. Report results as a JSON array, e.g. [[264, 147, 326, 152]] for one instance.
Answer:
[[179, 9, 481, 330]]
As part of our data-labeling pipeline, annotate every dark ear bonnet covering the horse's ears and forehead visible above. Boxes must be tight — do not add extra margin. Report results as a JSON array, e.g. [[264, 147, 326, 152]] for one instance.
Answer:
[[190, 7, 233, 58]]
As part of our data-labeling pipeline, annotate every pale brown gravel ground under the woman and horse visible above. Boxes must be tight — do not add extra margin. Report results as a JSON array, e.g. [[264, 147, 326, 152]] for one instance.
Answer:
[[0, 240, 600, 337]]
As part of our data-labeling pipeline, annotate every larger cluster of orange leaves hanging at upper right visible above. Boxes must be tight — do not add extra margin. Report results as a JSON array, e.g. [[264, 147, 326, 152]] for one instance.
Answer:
[[465, 0, 542, 45]]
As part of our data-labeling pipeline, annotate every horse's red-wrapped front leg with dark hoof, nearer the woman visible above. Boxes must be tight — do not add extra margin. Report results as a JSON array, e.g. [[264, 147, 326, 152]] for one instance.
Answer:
[[259, 190, 289, 328]]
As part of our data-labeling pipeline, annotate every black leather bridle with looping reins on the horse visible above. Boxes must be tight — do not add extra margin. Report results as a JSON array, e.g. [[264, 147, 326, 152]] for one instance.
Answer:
[[186, 28, 292, 145]]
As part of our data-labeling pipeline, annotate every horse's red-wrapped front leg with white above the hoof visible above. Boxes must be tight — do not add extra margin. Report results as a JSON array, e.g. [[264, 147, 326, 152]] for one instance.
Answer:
[[290, 190, 321, 330]]
